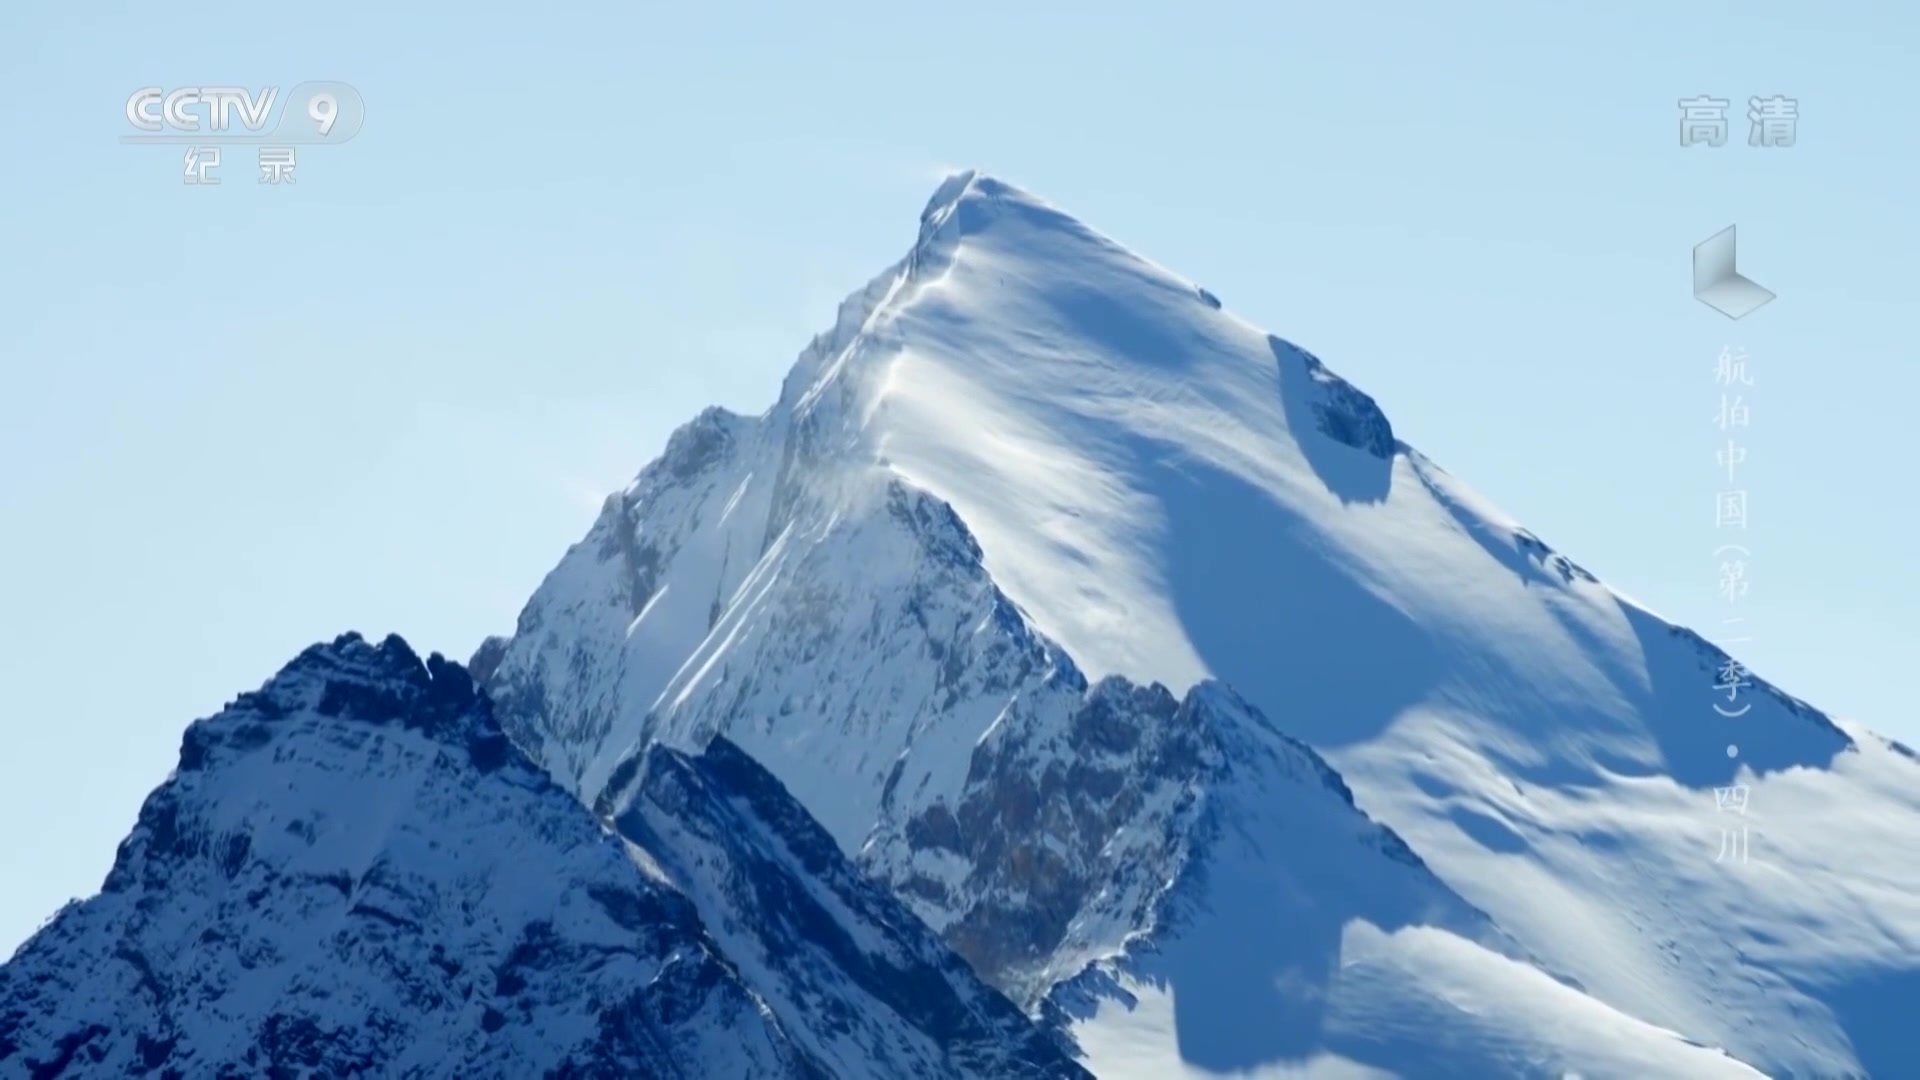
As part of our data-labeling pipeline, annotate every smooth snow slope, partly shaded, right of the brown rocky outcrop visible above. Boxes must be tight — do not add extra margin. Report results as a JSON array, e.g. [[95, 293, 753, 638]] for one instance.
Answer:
[[1044, 682, 1761, 1080]]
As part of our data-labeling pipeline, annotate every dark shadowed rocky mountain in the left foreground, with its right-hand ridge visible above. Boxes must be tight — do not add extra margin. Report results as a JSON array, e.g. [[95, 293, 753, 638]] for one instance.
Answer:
[[0, 634, 1083, 1080]]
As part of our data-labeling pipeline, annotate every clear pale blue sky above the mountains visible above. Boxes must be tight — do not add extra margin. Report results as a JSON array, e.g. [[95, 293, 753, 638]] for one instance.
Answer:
[[0, 0, 1920, 953]]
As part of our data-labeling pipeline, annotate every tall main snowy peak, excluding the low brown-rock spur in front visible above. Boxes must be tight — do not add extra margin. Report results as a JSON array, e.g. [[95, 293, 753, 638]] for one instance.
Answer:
[[490, 175, 1920, 1076]]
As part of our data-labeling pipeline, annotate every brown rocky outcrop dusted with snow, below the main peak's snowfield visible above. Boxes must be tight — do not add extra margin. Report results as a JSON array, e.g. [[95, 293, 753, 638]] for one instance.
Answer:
[[870, 676, 1430, 1013]]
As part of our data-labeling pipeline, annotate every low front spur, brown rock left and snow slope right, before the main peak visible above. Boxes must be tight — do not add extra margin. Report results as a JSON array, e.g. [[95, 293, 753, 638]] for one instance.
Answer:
[[890, 676, 1759, 1080]]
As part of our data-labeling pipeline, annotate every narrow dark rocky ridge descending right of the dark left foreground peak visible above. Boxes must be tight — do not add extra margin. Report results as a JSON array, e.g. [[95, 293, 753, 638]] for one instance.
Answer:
[[609, 738, 1087, 1080]]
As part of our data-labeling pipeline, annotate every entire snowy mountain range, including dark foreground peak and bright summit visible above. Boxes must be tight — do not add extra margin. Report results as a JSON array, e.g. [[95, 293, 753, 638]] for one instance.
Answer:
[[0, 173, 1920, 1080]]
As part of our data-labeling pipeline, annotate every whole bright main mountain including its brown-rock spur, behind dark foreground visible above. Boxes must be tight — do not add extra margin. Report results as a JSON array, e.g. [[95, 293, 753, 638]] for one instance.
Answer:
[[486, 173, 1920, 1080]]
